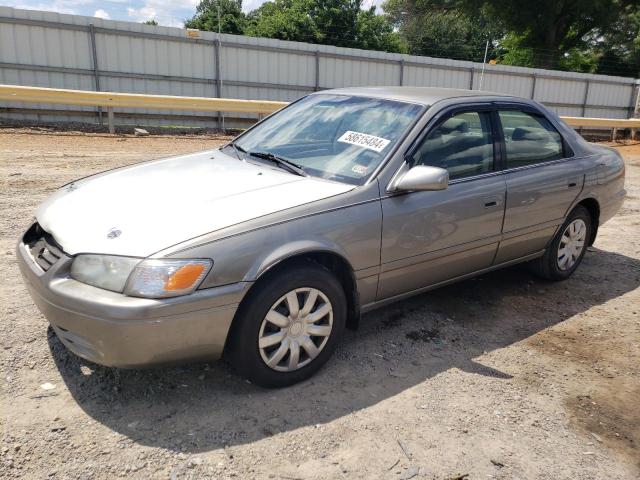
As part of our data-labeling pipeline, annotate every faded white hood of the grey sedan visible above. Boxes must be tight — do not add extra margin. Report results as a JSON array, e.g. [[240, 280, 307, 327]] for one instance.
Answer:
[[36, 150, 354, 257]]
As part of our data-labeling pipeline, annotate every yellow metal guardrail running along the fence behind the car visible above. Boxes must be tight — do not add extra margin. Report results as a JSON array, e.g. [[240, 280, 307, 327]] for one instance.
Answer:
[[0, 85, 640, 138]]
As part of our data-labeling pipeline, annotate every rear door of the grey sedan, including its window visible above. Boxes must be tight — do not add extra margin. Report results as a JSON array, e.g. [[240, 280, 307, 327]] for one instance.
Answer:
[[495, 104, 584, 263]]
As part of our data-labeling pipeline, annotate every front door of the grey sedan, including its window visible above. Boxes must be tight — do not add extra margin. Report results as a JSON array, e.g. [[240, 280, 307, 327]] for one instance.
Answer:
[[378, 107, 506, 300]]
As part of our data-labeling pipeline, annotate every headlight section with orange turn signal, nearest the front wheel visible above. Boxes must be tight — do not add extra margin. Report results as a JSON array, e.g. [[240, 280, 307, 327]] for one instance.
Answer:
[[125, 259, 211, 298]]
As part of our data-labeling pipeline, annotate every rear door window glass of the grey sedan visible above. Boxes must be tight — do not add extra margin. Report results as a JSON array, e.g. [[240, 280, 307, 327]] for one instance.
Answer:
[[498, 110, 563, 168]]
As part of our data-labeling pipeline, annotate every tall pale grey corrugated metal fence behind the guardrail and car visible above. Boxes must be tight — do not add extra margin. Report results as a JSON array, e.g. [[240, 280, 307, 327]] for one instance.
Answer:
[[0, 7, 638, 126]]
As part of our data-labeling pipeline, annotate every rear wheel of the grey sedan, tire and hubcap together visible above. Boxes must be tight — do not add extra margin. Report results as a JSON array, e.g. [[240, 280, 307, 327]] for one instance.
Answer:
[[529, 205, 593, 281]]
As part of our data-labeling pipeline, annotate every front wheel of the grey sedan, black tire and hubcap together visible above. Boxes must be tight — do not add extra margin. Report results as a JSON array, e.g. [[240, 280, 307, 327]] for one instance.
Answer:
[[228, 261, 347, 388]]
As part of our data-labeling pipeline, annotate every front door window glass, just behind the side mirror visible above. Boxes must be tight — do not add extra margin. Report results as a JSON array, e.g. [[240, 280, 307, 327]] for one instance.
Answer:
[[412, 112, 494, 180]]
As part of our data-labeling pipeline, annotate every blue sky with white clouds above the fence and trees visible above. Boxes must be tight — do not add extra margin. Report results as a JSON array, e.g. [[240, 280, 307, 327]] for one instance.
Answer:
[[0, 0, 381, 27]]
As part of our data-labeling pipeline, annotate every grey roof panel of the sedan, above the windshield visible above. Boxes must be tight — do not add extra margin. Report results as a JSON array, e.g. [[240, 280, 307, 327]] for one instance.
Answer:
[[315, 86, 513, 105]]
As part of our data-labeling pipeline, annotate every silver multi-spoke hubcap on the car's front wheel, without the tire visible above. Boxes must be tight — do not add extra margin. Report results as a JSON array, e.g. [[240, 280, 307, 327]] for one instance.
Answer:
[[258, 288, 333, 372]]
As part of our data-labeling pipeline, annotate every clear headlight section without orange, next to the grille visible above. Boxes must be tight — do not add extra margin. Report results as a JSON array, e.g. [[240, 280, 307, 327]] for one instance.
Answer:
[[71, 255, 141, 292]]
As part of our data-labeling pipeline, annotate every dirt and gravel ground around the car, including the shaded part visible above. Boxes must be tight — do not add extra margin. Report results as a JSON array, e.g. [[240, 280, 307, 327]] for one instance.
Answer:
[[0, 129, 640, 480]]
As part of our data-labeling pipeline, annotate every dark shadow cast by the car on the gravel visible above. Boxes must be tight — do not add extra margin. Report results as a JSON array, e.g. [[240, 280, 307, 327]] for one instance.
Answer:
[[49, 249, 640, 453]]
